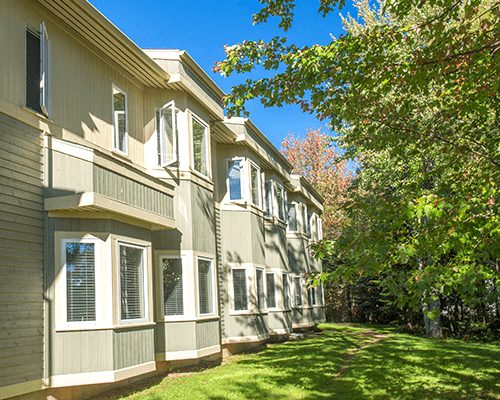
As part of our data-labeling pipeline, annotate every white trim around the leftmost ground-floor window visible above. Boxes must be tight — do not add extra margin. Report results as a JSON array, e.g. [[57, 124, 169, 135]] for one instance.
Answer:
[[57, 238, 102, 329]]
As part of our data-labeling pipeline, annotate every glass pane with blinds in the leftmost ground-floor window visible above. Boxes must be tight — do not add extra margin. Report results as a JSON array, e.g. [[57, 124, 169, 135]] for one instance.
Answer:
[[66, 243, 96, 322]]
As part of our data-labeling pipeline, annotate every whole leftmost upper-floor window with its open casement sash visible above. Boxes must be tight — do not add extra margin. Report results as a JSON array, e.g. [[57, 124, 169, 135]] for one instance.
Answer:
[[26, 22, 50, 117]]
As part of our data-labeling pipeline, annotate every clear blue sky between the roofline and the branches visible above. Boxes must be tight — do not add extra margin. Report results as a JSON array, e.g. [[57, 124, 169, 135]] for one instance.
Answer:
[[90, 0, 355, 149]]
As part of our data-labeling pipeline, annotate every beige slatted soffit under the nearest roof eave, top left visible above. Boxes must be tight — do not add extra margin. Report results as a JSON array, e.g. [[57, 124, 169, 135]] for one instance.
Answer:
[[37, 0, 170, 88]]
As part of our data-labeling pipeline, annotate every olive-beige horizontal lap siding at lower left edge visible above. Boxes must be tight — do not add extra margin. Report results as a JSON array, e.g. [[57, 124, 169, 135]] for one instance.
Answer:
[[0, 113, 43, 387]]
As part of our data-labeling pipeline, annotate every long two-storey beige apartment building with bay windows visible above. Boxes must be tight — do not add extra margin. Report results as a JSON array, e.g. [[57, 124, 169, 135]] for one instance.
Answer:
[[0, 0, 324, 399]]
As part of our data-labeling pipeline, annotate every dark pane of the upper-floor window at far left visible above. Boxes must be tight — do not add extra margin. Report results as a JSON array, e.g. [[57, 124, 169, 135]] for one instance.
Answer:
[[26, 31, 42, 114]]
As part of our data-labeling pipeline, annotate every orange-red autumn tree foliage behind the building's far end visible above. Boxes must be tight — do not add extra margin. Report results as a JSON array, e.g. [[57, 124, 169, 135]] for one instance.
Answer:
[[281, 128, 352, 240]]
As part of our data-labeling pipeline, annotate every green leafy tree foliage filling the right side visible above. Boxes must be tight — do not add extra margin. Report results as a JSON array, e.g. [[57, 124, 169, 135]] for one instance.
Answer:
[[215, 0, 500, 312]]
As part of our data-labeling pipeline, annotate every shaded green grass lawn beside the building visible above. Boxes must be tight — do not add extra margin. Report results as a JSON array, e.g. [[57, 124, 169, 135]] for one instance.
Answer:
[[96, 324, 500, 400]]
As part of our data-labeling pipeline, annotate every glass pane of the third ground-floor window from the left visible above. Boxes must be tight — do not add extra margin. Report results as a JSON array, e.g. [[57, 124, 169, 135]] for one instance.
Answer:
[[162, 258, 184, 315]]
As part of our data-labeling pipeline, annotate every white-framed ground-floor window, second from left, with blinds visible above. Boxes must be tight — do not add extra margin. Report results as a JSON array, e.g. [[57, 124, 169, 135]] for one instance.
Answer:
[[118, 243, 147, 322]]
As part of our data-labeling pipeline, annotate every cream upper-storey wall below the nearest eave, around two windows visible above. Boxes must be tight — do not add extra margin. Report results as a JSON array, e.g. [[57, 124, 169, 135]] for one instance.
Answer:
[[0, 0, 144, 165]]
